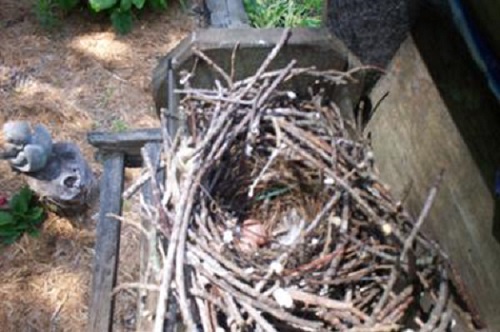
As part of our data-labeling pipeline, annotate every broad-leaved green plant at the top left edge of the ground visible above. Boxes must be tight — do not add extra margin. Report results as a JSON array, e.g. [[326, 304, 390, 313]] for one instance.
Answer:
[[35, 0, 167, 34]]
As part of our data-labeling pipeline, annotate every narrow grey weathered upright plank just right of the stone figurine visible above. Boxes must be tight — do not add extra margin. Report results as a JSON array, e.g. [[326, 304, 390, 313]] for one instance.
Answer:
[[87, 152, 124, 332]]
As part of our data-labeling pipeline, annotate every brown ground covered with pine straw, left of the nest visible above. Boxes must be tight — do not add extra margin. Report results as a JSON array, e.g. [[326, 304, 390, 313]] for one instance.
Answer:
[[0, 0, 195, 332]]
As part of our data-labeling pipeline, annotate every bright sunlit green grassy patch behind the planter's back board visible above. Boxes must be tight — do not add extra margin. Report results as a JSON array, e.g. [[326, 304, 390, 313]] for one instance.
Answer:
[[243, 0, 323, 28]]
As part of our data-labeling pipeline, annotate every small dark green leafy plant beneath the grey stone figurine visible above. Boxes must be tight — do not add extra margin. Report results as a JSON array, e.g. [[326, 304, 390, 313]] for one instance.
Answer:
[[0, 187, 45, 244]]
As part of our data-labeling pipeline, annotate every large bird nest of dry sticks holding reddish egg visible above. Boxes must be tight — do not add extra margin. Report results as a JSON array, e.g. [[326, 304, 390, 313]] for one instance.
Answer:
[[135, 29, 452, 331]]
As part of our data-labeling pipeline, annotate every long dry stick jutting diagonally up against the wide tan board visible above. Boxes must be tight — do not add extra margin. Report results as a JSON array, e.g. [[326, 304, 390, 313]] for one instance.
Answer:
[[369, 171, 444, 324]]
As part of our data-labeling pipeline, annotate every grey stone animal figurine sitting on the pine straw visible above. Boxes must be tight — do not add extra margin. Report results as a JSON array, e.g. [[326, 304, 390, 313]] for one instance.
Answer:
[[0, 121, 98, 214]]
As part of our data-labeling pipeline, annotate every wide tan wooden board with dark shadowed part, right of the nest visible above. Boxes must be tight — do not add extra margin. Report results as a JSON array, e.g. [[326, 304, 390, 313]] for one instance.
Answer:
[[367, 7, 500, 331]]
